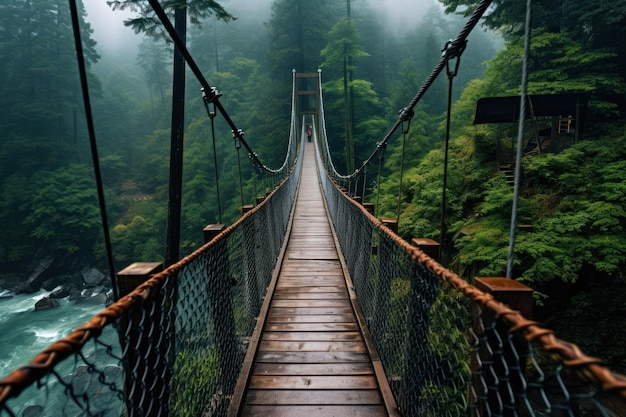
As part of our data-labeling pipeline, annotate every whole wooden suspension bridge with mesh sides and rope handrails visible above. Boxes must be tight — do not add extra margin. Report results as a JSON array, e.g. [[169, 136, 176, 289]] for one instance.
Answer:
[[0, 2, 626, 417]]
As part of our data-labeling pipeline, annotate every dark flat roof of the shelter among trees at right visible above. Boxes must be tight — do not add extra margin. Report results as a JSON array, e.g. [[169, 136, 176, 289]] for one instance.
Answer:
[[474, 94, 586, 125]]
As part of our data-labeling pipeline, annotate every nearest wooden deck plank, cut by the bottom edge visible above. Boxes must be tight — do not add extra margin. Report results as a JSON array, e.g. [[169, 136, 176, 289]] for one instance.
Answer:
[[241, 405, 387, 417]]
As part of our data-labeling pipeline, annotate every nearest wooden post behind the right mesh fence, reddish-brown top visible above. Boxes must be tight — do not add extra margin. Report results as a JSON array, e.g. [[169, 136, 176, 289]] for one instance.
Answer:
[[471, 277, 533, 417]]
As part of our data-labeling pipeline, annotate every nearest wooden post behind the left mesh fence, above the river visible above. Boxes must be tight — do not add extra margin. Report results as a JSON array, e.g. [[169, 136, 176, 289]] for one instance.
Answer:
[[117, 262, 166, 417]]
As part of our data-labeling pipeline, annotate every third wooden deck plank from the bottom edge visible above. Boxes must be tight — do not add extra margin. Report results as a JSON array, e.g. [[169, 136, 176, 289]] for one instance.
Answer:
[[248, 375, 378, 390]]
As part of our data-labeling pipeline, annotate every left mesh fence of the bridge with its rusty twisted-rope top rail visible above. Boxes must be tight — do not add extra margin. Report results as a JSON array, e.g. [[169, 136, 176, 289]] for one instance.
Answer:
[[0, 137, 301, 417]]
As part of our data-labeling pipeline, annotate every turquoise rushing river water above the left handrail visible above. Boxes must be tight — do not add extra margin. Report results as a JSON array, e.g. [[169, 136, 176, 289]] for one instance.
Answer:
[[0, 290, 105, 378]]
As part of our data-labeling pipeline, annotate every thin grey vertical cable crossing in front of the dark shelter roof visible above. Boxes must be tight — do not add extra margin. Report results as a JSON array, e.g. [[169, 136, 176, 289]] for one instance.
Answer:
[[506, 0, 531, 278]]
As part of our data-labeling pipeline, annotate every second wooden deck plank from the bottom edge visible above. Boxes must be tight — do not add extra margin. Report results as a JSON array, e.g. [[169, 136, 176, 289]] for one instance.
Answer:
[[246, 390, 382, 405]]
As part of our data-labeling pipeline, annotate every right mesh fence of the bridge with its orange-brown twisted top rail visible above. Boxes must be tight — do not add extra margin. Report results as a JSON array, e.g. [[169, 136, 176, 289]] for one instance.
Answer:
[[318, 138, 626, 417]]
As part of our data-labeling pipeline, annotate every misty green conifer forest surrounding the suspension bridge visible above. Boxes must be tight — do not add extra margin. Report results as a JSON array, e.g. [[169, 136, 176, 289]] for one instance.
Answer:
[[0, 0, 626, 372]]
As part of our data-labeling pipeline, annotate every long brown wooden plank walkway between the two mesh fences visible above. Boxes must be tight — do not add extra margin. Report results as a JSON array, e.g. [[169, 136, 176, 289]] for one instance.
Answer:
[[231, 143, 396, 417]]
